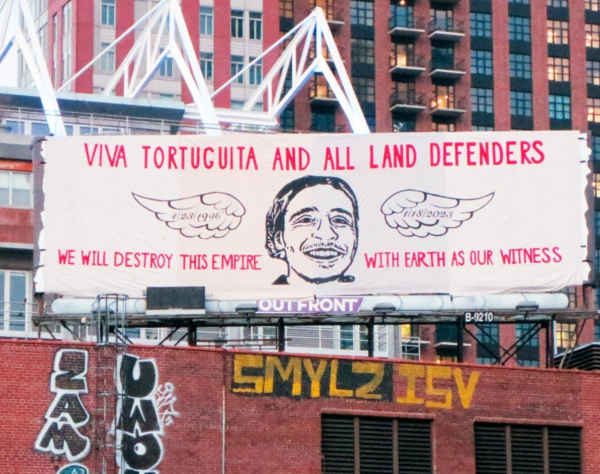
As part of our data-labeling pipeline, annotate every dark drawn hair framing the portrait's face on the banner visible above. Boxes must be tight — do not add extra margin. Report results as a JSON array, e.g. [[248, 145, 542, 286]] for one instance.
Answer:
[[265, 176, 358, 260]]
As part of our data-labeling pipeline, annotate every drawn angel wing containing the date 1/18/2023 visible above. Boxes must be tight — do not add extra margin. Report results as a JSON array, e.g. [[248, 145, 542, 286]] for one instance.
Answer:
[[381, 189, 494, 238]]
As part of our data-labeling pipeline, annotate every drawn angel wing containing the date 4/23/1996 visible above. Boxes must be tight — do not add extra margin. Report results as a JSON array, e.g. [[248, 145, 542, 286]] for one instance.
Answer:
[[132, 193, 246, 239]]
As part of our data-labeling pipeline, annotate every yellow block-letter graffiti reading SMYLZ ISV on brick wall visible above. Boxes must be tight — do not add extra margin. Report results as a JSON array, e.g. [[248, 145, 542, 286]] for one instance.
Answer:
[[232, 354, 480, 409]]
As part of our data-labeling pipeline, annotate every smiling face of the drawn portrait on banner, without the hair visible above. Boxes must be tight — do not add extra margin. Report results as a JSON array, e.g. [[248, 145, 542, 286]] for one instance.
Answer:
[[276, 185, 357, 283]]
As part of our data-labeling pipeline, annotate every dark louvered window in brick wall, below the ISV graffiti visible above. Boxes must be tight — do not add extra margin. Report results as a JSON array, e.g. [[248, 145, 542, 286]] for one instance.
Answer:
[[321, 412, 432, 474]]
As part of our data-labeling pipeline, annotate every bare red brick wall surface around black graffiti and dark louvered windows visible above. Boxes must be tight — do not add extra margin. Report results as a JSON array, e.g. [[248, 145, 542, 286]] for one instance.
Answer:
[[0, 340, 600, 474]]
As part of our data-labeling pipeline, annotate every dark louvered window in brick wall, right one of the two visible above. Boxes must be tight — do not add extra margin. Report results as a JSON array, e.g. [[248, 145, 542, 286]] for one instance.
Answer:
[[474, 423, 581, 474]]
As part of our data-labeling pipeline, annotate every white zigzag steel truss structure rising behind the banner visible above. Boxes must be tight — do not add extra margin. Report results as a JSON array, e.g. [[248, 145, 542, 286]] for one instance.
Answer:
[[0, 0, 369, 135]]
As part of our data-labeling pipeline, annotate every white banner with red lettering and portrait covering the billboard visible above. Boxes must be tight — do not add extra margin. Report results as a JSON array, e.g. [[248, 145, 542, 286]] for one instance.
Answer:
[[36, 131, 587, 300]]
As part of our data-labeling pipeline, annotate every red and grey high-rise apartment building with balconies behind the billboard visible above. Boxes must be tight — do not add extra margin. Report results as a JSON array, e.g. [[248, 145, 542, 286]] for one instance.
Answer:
[[0, 0, 600, 365]]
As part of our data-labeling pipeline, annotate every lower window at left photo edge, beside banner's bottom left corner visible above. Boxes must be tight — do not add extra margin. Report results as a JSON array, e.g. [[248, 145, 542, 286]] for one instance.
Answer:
[[0, 270, 31, 331]]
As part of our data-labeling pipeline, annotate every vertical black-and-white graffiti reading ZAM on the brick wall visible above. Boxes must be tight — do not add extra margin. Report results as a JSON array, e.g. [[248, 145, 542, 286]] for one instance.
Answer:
[[35, 349, 91, 462]]
